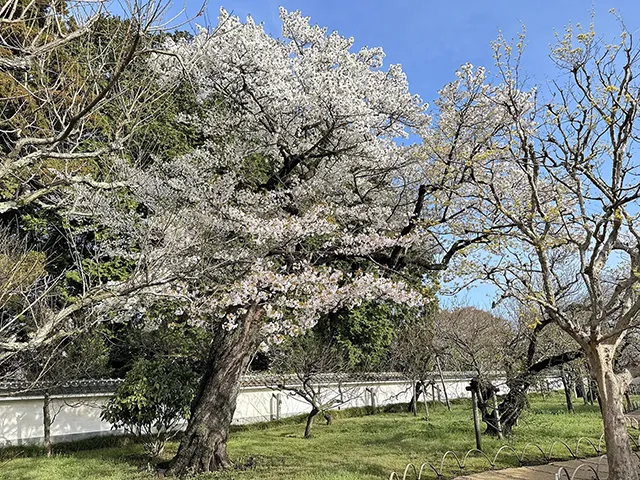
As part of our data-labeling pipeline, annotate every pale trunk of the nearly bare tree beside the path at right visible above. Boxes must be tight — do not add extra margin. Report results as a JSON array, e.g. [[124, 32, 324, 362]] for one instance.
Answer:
[[587, 345, 638, 480]]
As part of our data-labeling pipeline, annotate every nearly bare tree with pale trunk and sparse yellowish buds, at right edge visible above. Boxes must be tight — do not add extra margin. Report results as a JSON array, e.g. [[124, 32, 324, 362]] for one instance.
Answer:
[[434, 24, 640, 479]]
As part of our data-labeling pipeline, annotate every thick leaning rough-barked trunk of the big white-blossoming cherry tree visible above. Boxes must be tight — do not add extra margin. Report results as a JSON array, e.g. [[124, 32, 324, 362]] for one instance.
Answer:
[[170, 304, 263, 477]]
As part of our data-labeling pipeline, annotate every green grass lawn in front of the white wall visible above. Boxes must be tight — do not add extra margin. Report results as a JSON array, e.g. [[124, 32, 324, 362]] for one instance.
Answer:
[[0, 393, 620, 480]]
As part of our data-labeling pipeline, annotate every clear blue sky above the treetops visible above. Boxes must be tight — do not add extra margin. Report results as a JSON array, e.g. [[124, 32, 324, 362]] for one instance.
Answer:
[[158, 0, 640, 308]]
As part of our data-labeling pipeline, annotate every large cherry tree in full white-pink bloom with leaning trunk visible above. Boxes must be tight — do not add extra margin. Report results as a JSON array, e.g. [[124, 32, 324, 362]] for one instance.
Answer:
[[126, 9, 484, 475]]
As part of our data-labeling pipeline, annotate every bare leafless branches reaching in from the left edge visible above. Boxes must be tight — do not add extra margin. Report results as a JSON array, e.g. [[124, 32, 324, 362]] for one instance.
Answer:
[[0, 0, 202, 362]]
